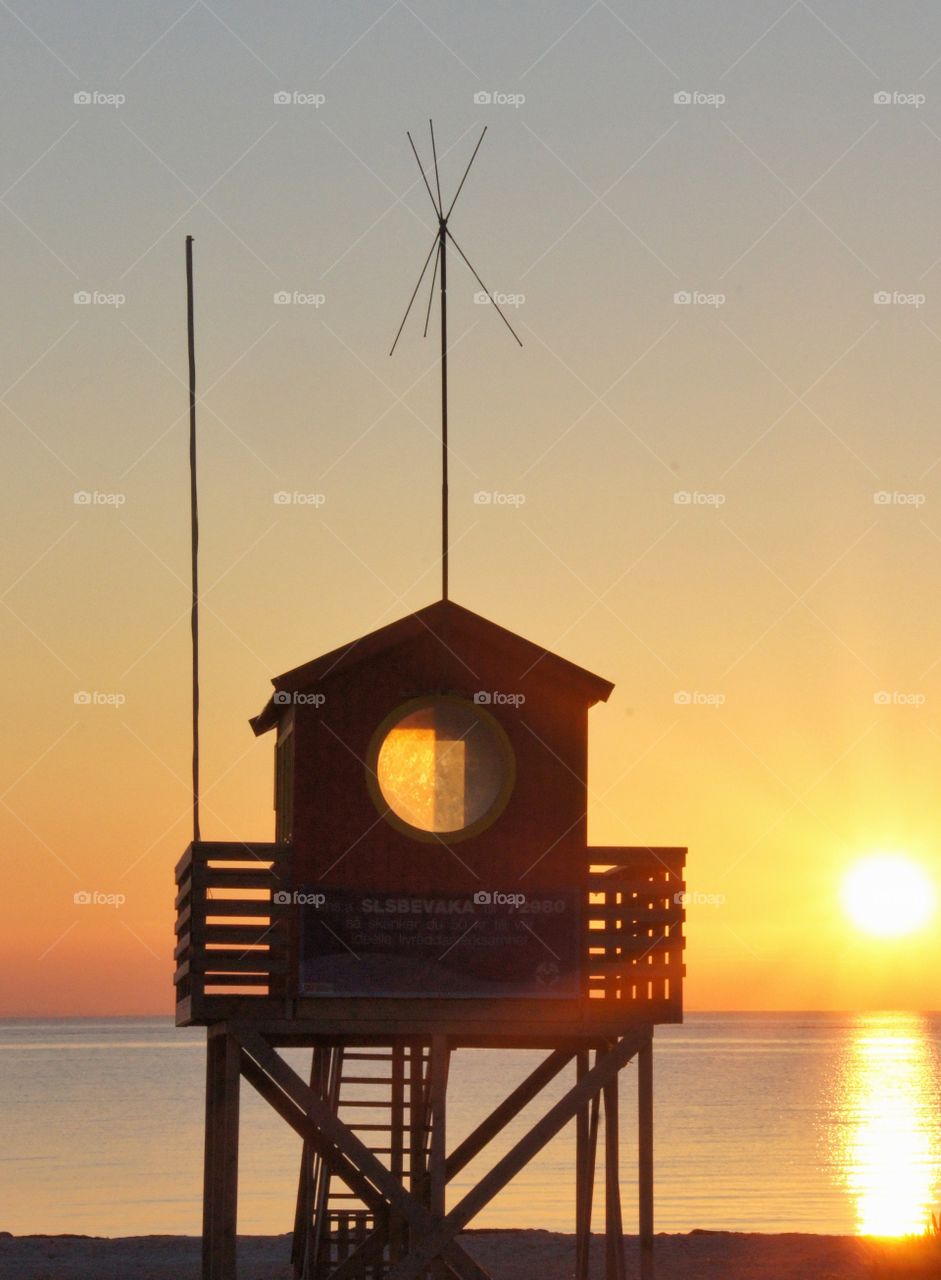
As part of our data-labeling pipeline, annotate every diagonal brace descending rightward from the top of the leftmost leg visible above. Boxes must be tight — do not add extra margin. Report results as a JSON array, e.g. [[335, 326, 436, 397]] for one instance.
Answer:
[[230, 1027, 489, 1280]]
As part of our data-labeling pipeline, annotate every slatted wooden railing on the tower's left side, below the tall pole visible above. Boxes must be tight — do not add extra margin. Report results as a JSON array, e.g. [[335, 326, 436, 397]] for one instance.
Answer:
[[174, 840, 288, 1007]]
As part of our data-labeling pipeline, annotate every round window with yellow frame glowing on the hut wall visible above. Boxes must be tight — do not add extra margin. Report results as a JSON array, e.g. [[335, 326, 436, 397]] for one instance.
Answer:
[[369, 695, 515, 840]]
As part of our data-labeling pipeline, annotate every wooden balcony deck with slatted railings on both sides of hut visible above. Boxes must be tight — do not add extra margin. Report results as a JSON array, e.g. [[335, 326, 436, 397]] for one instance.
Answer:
[[174, 841, 686, 1047]]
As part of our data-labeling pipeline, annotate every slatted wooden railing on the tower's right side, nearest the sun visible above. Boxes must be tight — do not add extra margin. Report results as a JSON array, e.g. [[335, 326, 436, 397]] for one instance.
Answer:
[[585, 847, 686, 1020]]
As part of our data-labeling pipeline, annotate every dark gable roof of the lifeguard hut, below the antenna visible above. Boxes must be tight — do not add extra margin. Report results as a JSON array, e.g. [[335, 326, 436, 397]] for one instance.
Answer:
[[250, 600, 615, 735]]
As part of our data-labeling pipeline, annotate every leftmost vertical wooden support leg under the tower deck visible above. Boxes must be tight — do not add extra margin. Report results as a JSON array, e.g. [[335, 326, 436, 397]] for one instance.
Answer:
[[202, 1030, 239, 1280]]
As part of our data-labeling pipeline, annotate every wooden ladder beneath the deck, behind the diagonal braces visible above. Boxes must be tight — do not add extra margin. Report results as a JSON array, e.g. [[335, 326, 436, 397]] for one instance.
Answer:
[[291, 1041, 430, 1280]]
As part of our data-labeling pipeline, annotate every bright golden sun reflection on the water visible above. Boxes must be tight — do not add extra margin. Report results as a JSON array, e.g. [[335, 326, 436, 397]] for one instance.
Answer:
[[840, 1014, 941, 1236]]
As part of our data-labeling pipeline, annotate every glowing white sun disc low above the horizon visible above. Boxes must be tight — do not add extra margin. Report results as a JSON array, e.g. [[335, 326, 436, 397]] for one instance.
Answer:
[[842, 854, 935, 938]]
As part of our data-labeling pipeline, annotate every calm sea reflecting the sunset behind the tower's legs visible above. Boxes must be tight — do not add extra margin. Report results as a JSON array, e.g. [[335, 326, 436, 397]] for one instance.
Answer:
[[0, 1014, 941, 1235]]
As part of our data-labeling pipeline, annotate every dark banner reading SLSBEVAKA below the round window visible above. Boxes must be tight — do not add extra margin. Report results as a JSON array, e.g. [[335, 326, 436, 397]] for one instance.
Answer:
[[302, 886, 580, 1000]]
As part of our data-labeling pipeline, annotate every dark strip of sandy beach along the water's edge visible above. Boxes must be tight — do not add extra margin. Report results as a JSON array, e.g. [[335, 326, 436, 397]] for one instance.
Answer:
[[0, 1231, 901, 1280]]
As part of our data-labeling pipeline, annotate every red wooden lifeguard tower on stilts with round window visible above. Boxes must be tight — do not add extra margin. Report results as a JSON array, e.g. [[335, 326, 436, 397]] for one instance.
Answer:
[[175, 124, 685, 1280]]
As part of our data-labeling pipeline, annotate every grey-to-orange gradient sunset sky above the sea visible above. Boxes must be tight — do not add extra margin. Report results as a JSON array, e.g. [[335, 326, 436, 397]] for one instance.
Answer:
[[0, 0, 941, 1014]]
